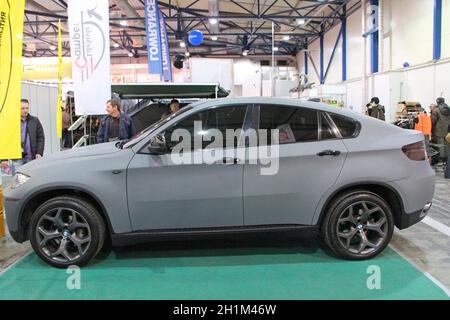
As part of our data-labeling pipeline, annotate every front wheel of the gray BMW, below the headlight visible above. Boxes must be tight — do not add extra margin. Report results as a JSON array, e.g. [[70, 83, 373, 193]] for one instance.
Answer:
[[28, 197, 106, 268]]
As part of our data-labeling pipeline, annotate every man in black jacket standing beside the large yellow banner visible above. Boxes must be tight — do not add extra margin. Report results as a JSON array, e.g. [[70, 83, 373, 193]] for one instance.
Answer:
[[14, 99, 45, 168]]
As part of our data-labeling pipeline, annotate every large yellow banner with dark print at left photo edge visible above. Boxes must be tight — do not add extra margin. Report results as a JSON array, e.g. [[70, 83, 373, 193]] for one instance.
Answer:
[[0, 0, 25, 159]]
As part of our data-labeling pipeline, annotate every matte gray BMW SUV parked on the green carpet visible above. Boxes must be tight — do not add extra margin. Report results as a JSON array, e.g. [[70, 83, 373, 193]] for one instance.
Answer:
[[4, 98, 435, 267]]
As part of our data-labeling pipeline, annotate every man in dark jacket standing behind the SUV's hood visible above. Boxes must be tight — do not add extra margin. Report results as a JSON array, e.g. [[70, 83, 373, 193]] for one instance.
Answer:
[[97, 99, 134, 143]]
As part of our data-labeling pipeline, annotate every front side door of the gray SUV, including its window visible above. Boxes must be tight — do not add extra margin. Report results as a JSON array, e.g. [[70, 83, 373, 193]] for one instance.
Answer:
[[127, 106, 247, 231]]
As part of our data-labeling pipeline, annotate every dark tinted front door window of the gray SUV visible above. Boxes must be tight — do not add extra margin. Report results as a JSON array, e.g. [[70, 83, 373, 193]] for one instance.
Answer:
[[165, 106, 247, 149]]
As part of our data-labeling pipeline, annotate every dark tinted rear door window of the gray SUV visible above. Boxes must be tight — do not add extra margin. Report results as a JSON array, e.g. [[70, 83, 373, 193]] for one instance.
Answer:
[[259, 105, 319, 144]]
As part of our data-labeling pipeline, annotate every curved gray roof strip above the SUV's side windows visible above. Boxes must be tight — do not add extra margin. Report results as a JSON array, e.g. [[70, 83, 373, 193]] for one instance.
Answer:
[[191, 97, 362, 118]]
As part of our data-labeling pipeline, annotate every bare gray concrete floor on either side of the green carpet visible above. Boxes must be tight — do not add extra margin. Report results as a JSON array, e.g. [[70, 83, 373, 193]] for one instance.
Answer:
[[0, 170, 450, 292]]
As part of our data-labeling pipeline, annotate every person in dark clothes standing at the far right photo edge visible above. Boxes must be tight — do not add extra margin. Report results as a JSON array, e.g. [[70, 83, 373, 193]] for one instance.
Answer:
[[431, 98, 450, 162]]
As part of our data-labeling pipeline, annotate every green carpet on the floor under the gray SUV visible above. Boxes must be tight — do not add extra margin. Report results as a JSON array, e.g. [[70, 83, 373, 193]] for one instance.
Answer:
[[0, 239, 449, 300]]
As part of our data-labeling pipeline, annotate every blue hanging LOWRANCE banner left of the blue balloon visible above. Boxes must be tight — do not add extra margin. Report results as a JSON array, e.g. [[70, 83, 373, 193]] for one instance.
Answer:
[[145, 0, 172, 81]]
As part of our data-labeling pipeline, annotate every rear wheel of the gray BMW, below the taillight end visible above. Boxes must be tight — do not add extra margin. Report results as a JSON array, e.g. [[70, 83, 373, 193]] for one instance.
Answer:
[[321, 190, 394, 260]]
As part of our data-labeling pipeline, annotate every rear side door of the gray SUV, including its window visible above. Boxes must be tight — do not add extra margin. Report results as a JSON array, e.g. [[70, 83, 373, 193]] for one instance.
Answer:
[[244, 105, 347, 226]]
